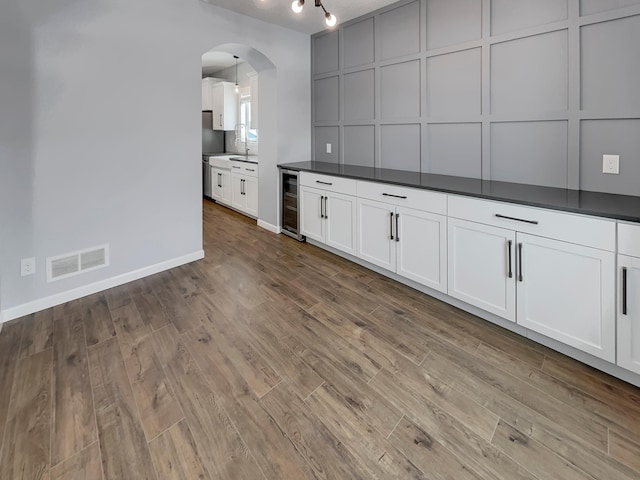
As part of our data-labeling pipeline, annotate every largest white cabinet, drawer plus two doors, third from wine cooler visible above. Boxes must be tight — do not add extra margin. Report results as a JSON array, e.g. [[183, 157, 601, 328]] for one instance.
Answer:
[[448, 199, 616, 362]]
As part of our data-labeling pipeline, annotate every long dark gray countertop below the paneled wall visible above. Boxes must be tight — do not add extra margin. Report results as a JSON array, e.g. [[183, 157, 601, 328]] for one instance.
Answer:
[[278, 162, 640, 223]]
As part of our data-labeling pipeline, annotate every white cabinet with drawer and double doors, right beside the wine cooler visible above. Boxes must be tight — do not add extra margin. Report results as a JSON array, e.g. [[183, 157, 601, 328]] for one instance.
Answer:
[[300, 172, 356, 255]]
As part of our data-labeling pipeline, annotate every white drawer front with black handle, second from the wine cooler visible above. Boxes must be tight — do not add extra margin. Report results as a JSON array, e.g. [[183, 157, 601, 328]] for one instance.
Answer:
[[358, 182, 447, 215]]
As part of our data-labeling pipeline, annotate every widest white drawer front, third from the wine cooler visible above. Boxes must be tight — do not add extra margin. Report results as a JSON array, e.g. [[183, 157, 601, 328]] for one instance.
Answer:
[[449, 195, 616, 252]]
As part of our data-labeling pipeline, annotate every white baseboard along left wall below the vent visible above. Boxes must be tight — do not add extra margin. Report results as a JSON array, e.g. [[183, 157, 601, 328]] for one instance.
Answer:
[[0, 250, 204, 328]]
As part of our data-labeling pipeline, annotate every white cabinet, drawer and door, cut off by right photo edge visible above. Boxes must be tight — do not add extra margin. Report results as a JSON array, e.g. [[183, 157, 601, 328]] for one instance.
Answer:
[[616, 223, 640, 374]]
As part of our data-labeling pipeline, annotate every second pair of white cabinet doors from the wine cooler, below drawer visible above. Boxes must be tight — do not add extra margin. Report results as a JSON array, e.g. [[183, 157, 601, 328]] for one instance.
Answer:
[[357, 198, 447, 292]]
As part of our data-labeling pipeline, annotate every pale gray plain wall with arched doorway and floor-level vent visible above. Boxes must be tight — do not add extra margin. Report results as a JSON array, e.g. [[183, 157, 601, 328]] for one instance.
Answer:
[[0, 0, 310, 320]]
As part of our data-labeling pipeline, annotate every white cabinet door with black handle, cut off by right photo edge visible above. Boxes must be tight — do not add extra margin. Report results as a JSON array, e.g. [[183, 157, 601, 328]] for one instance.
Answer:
[[617, 255, 640, 373]]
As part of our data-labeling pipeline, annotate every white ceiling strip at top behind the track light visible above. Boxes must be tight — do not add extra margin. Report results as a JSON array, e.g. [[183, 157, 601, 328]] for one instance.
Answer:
[[205, 0, 397, 34]]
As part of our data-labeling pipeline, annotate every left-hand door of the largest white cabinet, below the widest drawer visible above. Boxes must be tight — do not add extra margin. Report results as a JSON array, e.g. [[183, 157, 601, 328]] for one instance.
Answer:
[[447, 217, 516, 322]]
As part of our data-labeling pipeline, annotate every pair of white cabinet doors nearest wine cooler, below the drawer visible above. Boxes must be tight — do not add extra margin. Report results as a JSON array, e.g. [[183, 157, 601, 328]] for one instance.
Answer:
[[300, 186, 356, 255]]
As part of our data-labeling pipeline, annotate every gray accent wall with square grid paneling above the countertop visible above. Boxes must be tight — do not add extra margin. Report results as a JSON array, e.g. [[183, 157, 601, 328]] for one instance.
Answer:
[[311, 0, 640, 196]]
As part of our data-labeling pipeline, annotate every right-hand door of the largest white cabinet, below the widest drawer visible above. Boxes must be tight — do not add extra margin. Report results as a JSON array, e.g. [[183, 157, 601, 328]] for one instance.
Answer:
[[517, 233, 616, 362]]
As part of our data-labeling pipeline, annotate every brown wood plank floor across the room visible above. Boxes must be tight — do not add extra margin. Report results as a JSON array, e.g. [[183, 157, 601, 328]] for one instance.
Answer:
[[0, 201, 640, 480]]
